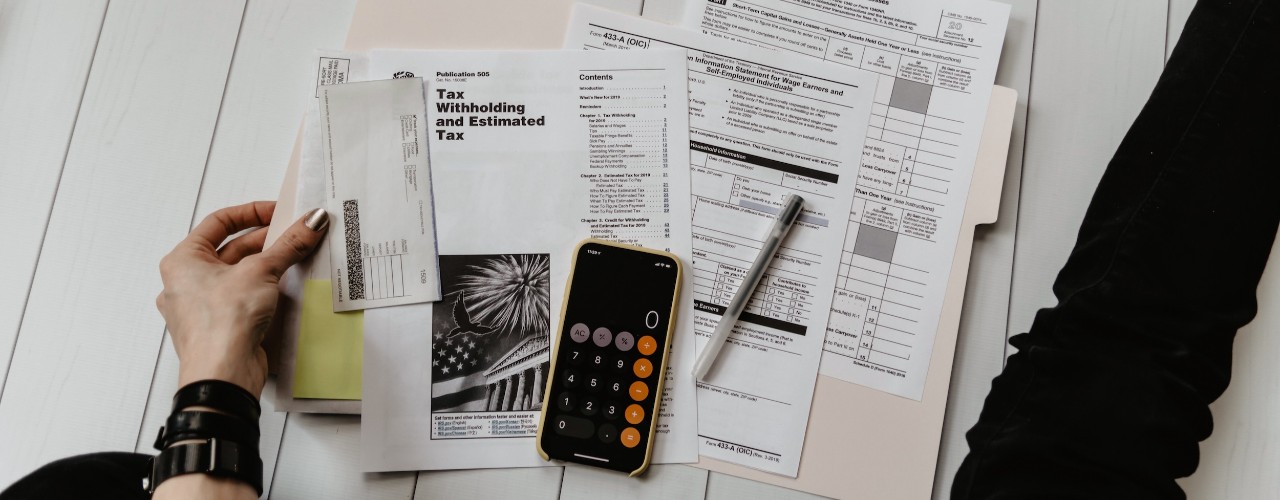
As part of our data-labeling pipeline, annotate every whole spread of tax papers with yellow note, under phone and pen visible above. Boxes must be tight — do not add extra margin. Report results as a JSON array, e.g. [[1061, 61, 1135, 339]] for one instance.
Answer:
[[270, 0, 1007, 488]]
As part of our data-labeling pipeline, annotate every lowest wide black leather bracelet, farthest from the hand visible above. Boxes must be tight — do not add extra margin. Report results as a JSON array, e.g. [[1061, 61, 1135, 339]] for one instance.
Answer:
[[143, 437, 262, 496]]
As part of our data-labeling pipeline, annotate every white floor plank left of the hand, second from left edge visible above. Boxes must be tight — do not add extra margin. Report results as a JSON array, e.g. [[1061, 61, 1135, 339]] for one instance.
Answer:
[[0, 0, 244, 485]]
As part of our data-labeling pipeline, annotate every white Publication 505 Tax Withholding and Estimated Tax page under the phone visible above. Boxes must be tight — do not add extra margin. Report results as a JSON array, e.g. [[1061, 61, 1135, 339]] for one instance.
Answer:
[[361, 50, 698, 471]]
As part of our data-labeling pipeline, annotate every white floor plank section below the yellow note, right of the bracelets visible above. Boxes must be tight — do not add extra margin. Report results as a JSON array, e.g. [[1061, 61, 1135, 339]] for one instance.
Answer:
[[270, 413, 414, 500]]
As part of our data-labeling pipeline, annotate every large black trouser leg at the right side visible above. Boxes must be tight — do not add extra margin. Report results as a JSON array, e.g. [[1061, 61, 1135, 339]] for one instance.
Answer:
[[952, 0, 1280, 499]]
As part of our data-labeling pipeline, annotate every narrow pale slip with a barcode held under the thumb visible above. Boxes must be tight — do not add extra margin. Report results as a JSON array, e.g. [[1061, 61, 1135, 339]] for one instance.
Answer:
[[319, 78, 440, 312]]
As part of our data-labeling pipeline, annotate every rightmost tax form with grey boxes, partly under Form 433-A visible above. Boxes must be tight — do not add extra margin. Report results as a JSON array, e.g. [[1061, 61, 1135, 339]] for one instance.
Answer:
[[685, 0, 1009, 400]]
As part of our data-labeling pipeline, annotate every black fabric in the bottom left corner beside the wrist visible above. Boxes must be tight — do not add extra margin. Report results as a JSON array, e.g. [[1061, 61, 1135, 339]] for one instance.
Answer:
[[0, 451, 151, 500]]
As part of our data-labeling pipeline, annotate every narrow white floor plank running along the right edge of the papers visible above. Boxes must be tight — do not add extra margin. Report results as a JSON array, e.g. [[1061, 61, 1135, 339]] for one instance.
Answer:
[[933, 0, 1037, 499]]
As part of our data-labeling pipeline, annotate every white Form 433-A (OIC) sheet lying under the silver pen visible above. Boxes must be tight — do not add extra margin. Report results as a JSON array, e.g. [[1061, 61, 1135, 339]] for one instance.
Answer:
[[566, 4, 876, 477]]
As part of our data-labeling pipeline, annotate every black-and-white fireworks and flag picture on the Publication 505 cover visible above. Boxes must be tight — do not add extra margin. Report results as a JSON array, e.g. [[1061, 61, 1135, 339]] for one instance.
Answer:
[[431, 253, 550, 414]]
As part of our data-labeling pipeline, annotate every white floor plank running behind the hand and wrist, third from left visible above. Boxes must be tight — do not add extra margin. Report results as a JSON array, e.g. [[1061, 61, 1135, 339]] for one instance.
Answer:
[[128, 0, 356, 495]]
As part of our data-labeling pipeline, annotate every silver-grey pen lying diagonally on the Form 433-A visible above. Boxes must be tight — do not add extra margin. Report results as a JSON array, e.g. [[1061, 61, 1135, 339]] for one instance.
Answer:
[[694, 194, 804, 380]]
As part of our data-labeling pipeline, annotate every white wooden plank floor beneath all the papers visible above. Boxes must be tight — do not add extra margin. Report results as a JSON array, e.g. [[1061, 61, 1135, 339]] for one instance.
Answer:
[[0, 0, 1280, 499]]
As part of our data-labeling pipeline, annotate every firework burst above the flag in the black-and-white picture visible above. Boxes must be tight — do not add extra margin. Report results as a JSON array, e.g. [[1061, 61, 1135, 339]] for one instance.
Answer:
[[458, 254, 550, 336]]
